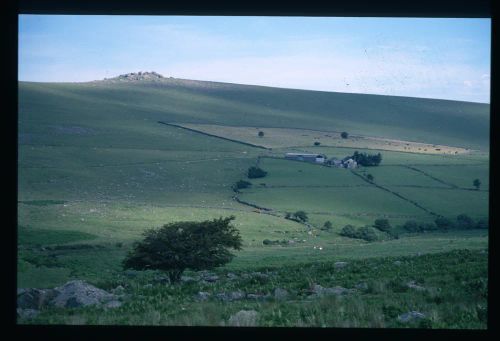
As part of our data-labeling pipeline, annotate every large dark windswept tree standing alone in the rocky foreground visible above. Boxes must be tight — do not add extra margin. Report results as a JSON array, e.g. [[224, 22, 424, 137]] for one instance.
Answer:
[[123, 216, 242, 283]]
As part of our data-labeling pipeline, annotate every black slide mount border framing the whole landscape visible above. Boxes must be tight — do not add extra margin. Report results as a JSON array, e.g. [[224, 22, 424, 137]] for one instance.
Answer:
[[5, 0, 500, 341]]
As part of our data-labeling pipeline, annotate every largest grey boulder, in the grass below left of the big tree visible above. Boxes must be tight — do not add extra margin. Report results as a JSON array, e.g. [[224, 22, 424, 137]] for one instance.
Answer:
[[50, 280, 115, 308]]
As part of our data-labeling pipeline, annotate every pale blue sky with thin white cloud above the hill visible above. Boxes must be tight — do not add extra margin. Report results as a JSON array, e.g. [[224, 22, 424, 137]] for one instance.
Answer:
[[19, 15, 491, 103]]
